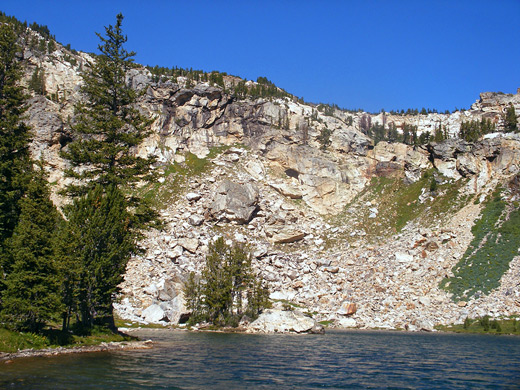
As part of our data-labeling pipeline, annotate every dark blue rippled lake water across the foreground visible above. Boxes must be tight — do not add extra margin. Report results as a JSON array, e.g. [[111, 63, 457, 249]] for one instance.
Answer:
[[0, 330, 520, 389]]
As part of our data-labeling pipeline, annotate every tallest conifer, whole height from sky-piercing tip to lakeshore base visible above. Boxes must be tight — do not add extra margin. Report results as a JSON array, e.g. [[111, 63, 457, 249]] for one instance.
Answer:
[[60, 14, 156, 328]]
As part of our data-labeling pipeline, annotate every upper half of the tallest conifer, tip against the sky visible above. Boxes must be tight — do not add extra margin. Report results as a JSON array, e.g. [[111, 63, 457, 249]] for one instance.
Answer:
[[63, 14, 154, 195]]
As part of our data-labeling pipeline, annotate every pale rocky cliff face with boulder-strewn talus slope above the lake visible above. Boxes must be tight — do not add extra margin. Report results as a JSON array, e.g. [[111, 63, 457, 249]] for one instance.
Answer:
[[18, 29, 520, 329]]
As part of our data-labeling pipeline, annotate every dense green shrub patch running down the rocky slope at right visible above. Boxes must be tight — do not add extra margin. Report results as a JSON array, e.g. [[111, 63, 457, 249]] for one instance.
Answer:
[[441, 189, 520, 300]]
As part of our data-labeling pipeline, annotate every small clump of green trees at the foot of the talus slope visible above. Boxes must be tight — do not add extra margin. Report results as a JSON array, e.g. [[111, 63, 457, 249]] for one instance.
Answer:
[[184, 237, 270, 326]]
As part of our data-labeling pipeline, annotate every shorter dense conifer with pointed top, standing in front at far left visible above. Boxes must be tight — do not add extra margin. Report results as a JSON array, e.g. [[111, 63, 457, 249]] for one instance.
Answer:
[[2, 164, 60, 332]]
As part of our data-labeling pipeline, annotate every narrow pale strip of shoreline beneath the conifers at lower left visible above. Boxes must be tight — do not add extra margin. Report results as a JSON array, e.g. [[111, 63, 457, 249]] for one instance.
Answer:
[[0, 340, 154, 364]]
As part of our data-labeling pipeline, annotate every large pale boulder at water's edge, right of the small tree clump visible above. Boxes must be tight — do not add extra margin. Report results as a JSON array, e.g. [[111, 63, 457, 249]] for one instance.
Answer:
[[249, 309, 320, 333]]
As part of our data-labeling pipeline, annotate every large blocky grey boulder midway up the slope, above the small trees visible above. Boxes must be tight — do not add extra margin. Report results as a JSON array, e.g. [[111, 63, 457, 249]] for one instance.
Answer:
[[210, 180, 258, 224]]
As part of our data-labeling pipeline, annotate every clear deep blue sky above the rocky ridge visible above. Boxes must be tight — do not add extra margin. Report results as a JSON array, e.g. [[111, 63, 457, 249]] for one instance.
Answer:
[[0, 0, 520, 111]]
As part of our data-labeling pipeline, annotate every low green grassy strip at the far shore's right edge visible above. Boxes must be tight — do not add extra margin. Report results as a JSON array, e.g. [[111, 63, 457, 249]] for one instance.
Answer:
[[435, 316, 520, 335]]
